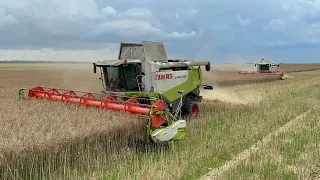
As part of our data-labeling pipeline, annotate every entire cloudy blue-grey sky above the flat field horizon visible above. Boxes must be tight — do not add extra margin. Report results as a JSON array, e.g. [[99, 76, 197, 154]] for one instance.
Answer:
[[0, 0, 320, 63]]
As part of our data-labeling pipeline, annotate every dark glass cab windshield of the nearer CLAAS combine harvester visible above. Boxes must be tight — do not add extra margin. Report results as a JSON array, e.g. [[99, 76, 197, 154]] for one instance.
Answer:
[[103, 64, 141, 92]]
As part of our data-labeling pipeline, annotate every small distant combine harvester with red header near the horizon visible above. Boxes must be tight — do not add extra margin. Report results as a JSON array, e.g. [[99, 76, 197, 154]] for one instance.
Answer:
[[239, 59, 284, 80]]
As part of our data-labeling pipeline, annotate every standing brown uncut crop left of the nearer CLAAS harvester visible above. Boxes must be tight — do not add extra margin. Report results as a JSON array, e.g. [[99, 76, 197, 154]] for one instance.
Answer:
[[0, 70, 146, 169]]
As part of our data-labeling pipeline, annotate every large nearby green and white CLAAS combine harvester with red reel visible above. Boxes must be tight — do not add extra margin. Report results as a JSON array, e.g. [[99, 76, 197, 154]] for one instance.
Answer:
[[19, 41, 212, 143]]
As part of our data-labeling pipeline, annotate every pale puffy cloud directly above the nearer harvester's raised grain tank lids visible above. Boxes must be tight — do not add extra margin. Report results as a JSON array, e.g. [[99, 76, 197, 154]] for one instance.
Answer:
[[93, 7, 197, 41]]
